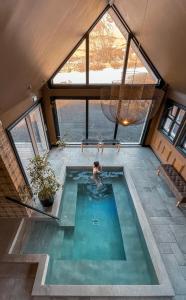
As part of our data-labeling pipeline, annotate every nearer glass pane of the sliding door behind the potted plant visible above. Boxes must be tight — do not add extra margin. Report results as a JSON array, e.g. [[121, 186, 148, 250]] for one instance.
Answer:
[[11, 119, 35, 176]]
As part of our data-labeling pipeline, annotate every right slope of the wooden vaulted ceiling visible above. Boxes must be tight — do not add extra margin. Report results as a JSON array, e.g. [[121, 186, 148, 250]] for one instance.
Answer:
[[115, 0, 186, 93]]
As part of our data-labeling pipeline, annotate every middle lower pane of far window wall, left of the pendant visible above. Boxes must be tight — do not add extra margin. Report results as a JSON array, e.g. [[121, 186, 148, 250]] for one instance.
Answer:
[[88, 100, 115, 140]]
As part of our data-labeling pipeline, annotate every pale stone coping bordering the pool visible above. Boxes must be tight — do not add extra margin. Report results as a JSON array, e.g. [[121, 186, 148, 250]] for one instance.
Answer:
[[1, 165, 175, 299]]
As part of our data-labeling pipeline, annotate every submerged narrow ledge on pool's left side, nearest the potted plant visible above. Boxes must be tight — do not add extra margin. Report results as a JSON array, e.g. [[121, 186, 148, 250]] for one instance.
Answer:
[[58, 181, 77, 227]]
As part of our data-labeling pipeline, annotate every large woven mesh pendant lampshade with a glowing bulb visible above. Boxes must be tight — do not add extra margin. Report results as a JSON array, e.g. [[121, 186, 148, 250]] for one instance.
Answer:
[[101, 84, 164, 126]]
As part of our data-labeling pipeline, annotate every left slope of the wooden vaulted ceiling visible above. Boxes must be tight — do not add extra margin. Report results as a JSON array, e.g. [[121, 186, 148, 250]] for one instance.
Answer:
[[0, 0, 107, 113]]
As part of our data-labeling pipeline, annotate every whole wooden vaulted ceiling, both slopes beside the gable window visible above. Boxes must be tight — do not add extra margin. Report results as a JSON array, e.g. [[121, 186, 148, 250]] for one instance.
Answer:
[[0, 0, 186, 113]]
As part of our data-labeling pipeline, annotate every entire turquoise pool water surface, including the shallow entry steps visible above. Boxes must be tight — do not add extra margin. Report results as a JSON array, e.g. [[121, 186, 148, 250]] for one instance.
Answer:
[[21, 168, 158, 285]]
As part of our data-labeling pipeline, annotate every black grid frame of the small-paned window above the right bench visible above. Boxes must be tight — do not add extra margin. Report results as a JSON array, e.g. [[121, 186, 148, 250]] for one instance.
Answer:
[[158, 99, 186, 145]]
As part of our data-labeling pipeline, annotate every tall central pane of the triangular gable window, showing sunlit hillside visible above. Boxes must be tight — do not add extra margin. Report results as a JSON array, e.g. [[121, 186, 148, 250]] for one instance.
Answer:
[[89, 12, 127, 84]]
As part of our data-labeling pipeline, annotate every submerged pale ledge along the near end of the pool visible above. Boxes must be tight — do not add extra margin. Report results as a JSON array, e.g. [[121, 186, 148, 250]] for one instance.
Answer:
[[46, 260, 151, 284]]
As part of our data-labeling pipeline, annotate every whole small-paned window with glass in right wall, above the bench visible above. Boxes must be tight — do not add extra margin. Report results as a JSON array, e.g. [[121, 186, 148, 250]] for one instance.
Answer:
[[160, 101, 186, 142]]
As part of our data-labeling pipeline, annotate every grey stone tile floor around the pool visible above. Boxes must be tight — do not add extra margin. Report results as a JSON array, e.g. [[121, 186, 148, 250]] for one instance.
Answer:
[[0, 147, 186, 300]]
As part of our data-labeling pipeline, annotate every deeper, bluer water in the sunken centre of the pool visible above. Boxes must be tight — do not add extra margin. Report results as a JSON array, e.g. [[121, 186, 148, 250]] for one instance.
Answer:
[[61, 184, 125, 260]]
